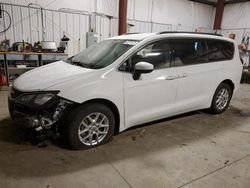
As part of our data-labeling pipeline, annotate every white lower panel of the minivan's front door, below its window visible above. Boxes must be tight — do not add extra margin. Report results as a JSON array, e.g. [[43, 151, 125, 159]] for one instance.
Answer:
[[124, 68, 177, 127]]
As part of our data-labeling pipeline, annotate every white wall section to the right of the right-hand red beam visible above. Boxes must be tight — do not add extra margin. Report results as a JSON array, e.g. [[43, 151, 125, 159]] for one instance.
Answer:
[[220, 2, 250, 43]]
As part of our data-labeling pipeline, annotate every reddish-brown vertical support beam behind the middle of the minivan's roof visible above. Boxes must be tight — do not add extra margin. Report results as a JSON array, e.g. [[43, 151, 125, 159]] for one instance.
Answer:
[[118, 0, 128, 35]]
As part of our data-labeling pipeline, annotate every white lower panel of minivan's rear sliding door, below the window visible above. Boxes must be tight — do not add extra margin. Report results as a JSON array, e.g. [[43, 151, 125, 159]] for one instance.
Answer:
[[176, 63, 220, 112]]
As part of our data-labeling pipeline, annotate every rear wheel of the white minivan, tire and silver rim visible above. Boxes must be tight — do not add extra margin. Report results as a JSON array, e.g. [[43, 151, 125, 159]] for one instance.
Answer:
[[209, 83, 233, 114]]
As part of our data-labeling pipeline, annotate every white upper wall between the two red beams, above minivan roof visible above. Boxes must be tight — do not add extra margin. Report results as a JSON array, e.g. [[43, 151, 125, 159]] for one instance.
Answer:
[[128, 0, 215, 31]]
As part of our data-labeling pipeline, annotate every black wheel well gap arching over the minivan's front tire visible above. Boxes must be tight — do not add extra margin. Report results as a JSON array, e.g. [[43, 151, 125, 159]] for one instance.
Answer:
[[82, 99, 120, 134]]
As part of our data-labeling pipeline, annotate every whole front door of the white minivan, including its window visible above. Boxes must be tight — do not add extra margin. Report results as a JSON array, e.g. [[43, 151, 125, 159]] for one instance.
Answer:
[[123, 41, 177, 127]]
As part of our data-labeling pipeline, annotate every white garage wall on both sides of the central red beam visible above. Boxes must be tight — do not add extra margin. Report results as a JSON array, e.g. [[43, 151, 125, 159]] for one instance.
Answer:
[[0, 0, 215, 55]]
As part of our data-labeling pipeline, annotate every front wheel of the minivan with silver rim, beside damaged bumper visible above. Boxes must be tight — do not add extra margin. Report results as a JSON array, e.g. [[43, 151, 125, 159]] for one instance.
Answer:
[[62, 103, 115, 149]]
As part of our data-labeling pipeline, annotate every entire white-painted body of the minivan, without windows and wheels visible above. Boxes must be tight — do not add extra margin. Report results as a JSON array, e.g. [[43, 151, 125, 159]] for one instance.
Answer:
[[14, 33, 242, 131]]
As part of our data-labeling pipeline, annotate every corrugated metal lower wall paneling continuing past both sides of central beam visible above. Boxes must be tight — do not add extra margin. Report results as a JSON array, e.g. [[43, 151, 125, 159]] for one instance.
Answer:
[[0, 4, 180, 56]]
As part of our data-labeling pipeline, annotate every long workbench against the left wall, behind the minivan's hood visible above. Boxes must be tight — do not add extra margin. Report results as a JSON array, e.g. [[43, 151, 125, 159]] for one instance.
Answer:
[[0, 52, 68, 86]]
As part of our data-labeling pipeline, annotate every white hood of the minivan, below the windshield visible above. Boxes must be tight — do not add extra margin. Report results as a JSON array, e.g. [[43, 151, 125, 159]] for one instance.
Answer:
[[13, 61, 94, 91]]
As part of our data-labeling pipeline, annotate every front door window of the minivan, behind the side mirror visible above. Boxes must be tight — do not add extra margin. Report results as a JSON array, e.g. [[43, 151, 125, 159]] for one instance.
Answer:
[[131, 41, 171, 70]]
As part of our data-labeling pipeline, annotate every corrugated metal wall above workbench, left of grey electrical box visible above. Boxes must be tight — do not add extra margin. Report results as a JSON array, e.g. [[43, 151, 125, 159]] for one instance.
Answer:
[[0, 4, 89, 55]]
